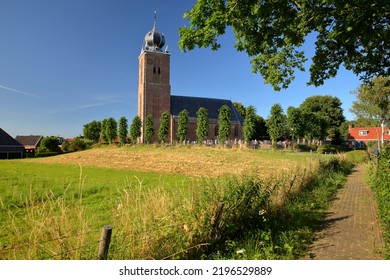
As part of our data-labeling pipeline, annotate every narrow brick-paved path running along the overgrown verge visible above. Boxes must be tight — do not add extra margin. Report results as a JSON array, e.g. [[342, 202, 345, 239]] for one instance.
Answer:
[[305, 165, 383, 260]]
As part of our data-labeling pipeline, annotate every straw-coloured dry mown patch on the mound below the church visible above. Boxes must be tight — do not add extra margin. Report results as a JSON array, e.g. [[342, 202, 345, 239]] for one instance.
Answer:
[[35, 147, 304, 177]]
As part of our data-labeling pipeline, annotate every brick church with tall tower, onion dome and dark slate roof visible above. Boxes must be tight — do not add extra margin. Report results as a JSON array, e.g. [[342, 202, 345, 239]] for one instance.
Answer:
[[138, 17, 244, 143]]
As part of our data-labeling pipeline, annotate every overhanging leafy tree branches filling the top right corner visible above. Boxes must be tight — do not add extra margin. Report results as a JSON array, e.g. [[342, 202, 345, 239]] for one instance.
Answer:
[[179, 0, 390, 90]]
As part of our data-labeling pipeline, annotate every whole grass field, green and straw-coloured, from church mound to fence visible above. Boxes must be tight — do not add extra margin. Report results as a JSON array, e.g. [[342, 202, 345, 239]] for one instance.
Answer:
[[0, 146, 348, 259]]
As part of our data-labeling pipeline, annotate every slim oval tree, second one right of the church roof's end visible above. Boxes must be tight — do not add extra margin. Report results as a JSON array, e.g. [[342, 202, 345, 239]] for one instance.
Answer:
[[266, 104, 286, 148]]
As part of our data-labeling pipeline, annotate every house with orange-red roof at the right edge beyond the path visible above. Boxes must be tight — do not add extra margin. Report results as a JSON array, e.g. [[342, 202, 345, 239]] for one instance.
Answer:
[[348, 126, 390, 148]]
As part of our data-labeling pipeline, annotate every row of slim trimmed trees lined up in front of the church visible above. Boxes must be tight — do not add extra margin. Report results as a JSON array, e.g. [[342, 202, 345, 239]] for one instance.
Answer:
[[83, 103, 266, 144]]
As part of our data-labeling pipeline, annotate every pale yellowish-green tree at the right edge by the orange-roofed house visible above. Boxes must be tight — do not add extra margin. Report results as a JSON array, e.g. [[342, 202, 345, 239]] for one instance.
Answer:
[[350, 77, 390, 148]]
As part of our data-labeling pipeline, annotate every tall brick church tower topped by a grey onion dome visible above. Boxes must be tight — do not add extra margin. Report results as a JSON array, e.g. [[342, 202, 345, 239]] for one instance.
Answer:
[[138, 15, 171, 143]]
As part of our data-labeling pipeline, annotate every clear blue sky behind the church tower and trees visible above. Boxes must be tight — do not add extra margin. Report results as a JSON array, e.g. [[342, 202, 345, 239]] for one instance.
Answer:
[[0, 0, 361, 137]]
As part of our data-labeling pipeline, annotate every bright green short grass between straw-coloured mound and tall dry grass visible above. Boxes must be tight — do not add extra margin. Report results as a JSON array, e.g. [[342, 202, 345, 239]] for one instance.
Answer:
[[0, 161, 189, 207]]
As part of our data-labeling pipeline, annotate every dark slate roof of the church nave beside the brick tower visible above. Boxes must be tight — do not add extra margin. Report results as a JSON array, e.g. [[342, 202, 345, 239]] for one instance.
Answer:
[[171, 95, 244, 125]]
